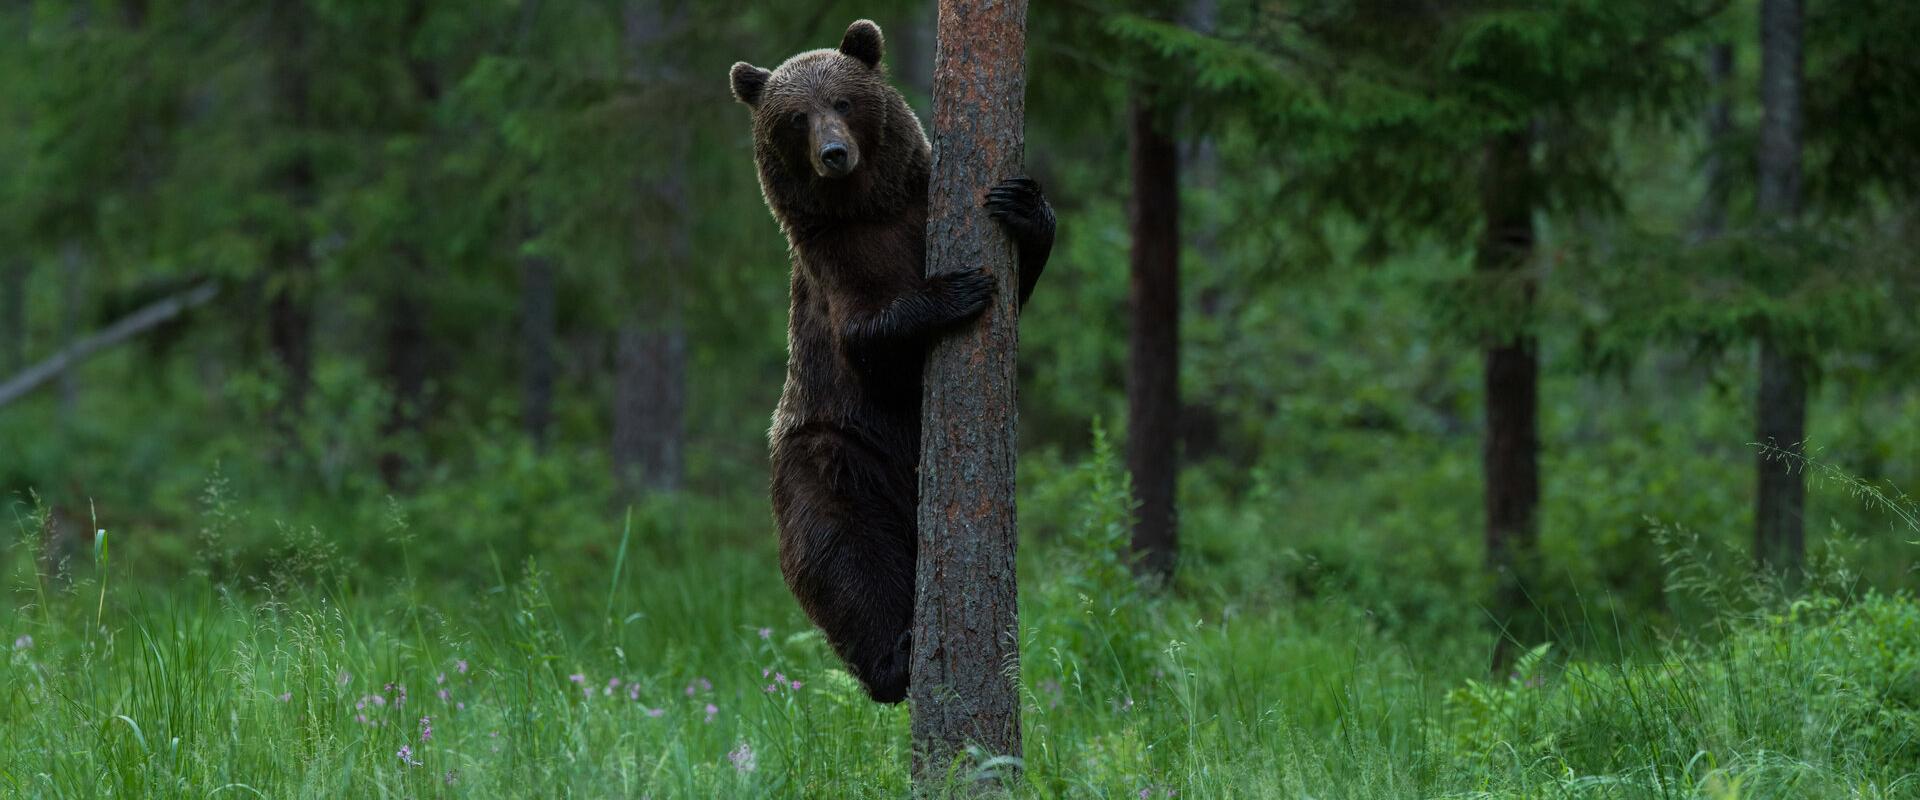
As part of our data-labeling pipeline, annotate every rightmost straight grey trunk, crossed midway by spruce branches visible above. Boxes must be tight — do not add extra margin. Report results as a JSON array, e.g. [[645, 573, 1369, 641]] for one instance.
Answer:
[[1753, 0, 1809, 574]]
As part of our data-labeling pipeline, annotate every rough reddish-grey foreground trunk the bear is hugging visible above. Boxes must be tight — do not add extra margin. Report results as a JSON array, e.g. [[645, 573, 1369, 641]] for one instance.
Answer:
[[912, 0, 1027, 792]]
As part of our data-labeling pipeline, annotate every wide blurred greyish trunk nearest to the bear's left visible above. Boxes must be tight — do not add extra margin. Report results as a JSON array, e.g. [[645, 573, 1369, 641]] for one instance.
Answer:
[[612, 0, 691, 497]]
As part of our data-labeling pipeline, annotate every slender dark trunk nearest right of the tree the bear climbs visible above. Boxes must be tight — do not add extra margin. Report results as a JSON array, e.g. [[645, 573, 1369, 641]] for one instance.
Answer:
[[1127, 96, 1181, 579]]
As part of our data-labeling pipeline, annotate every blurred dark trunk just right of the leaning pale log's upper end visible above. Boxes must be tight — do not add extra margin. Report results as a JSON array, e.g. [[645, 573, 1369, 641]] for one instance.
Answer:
[[267, 0, 315, 429]]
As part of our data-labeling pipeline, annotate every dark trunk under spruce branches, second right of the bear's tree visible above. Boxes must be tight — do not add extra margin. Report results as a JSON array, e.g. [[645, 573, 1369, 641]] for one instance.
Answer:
[[1475, 130, 1540, 670]]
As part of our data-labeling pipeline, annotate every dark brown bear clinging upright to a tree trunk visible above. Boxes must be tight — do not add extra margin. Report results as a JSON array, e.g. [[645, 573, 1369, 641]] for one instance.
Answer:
[[730, 19, 1054, 702]]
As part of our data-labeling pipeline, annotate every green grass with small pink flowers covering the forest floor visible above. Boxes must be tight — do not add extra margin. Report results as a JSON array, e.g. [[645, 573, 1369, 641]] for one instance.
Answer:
[[0, 441, 1920, 798]]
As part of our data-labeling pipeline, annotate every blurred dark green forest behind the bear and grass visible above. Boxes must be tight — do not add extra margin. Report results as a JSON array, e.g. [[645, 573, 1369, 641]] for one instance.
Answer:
[[0, 0, 1920, 796]]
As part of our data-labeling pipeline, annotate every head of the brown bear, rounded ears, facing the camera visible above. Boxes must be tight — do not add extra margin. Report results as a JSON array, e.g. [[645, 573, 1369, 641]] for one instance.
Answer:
[[730, 19, 925, 218]]
